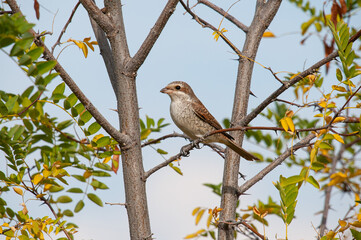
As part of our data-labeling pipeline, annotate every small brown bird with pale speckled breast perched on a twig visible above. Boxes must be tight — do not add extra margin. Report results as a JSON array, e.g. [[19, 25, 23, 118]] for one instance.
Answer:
[[160, 81, 259, 161]]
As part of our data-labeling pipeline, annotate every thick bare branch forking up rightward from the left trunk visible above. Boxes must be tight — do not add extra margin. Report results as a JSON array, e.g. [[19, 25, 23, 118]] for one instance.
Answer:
[[127, 0, 178, 72]]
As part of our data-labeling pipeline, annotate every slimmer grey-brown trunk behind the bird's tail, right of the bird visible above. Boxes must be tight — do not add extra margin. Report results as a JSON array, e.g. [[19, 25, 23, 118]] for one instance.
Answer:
[[218, 0, 281, 240]]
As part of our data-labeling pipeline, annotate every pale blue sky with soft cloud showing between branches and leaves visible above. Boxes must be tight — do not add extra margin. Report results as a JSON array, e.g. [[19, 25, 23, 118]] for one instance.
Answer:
[[0, 0, 361, 240]]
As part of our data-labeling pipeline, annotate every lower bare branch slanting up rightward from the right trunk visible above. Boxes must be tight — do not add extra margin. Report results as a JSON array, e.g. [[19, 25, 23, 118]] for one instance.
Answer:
[[238, 133, 316, 195]]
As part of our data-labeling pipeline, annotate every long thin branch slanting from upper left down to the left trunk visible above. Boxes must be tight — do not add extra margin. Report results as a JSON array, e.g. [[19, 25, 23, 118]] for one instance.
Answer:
[[7, 0, 130, 148]]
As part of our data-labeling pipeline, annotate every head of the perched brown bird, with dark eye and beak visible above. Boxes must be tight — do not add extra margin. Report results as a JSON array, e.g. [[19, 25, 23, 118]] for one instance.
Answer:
[[160, 81, 195, 100]]
